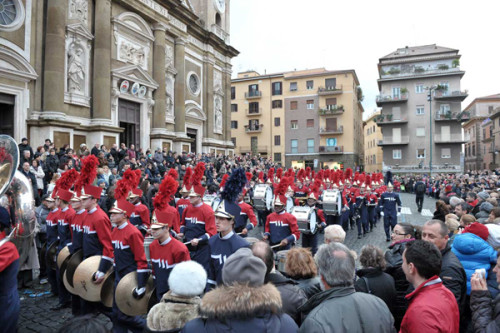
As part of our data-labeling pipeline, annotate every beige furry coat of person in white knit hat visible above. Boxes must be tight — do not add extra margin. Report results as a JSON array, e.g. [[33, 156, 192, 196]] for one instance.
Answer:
[[147, 291, 201, 332]]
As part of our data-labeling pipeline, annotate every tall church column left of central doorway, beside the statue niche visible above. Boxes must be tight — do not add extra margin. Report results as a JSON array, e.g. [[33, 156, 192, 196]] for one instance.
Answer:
[[92, 0, 112, 120]]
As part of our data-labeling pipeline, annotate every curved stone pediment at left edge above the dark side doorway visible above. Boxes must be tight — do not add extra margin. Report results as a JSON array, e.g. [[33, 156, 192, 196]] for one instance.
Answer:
[[0, 45, 38, 82]]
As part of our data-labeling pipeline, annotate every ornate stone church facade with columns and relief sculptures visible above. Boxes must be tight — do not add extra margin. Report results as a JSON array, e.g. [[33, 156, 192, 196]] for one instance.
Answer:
[[0, 0, 238, 154]]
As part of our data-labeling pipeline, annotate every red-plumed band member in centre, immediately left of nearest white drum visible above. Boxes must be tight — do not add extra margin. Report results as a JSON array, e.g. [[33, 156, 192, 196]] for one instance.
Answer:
[[263, 191, 300, 251]]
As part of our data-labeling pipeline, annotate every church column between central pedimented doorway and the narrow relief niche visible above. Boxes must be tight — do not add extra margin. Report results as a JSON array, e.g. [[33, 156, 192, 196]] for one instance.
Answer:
[[153, 23, 167, 129]]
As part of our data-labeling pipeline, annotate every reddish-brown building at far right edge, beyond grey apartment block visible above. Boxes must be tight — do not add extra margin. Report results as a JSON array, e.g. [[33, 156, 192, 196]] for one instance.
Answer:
[[462, 94, 500, 170]]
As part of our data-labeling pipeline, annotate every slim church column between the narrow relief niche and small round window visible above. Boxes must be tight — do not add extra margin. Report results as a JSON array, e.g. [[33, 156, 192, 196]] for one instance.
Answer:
[[174, 38, 186, 134]]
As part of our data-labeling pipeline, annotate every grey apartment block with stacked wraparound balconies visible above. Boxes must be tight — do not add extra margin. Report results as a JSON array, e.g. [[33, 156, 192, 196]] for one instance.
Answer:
[[375, 44, 467, 173]]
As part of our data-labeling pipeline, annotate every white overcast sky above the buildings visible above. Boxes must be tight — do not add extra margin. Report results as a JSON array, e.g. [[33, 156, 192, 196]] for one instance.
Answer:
[[230, 0, 500, 116]]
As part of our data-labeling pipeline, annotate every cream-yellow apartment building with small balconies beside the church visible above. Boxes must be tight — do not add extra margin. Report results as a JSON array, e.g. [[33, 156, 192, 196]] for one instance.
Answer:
[[231, 68, 364, 168]]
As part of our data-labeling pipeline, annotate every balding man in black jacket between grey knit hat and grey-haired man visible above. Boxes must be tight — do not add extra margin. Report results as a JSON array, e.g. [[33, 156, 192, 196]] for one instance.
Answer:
[[252, 241, 307, 325]]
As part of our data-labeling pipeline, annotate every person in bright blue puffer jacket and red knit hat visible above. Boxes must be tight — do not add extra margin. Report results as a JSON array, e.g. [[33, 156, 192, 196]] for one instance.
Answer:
[[451, 222, 497, 295]]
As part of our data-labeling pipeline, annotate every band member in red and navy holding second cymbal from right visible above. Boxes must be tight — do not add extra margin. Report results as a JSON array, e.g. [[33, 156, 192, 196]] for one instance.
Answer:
[[81, 185, 113, 304]]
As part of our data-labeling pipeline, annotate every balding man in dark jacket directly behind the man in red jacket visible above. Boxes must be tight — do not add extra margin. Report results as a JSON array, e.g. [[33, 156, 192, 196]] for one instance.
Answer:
[[422, 220, 467, 317]]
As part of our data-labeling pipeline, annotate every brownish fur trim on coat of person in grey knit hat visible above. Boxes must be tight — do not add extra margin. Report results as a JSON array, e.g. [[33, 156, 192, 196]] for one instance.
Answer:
[[200, 283, 282, 321]]
